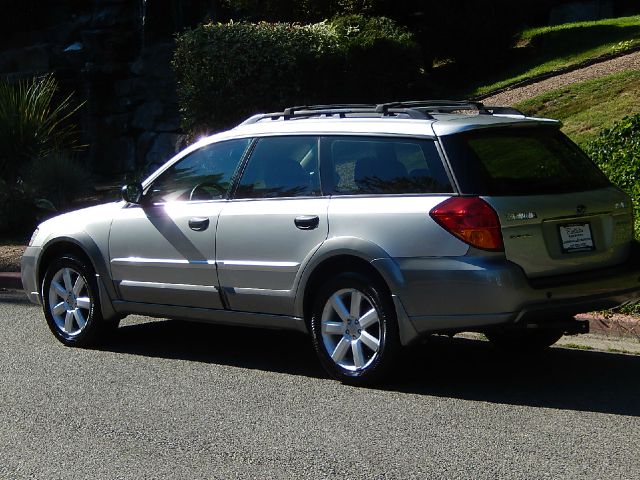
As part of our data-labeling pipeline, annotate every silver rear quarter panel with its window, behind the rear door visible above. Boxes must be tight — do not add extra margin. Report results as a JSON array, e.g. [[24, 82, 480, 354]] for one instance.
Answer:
[[321, 136, 460, 258]]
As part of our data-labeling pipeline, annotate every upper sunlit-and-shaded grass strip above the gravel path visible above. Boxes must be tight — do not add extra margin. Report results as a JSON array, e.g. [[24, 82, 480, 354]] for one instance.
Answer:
[[467, 15, 640, 95]]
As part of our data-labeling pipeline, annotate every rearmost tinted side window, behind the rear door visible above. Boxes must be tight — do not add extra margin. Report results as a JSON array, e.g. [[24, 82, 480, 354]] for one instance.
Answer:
[[327, 137, 452, 195]]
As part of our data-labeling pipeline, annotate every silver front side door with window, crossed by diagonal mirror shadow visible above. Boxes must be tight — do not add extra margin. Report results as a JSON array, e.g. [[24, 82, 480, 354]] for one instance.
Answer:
[[109, 139, 251, 308]]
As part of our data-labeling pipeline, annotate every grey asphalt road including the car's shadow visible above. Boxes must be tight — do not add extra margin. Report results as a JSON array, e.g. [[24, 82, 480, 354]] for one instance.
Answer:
[[0, 293, 640, 479]]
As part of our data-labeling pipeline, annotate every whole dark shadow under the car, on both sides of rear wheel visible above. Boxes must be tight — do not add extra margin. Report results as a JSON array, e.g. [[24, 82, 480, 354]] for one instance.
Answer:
[[101, 320, 640, 416]]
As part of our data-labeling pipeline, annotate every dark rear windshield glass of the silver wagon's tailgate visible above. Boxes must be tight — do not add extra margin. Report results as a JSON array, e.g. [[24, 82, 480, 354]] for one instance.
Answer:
[[442, 128, 609, 196]]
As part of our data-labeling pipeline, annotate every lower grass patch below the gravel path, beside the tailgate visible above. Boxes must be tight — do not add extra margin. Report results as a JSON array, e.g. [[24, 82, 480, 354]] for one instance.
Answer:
[[516, 70, 640, 145]]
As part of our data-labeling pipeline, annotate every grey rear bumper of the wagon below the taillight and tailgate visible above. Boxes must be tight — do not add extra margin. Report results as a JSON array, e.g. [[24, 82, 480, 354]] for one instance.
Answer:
[[378, 248, 640, 335]]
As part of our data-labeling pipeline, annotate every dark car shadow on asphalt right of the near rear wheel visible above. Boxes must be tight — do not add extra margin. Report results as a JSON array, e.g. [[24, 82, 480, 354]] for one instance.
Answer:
[[388, 337, 640, 416]]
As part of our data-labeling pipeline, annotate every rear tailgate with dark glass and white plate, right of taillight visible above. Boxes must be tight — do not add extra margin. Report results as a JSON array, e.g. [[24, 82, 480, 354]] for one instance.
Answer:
[[442, 126, 633, 278]]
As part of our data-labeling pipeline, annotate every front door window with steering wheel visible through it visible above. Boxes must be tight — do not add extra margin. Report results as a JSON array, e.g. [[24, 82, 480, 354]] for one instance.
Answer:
[[150, 138, 251, 203]]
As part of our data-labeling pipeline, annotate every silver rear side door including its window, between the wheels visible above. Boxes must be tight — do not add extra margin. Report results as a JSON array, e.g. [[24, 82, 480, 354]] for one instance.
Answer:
[[216, 136, 329, 315]]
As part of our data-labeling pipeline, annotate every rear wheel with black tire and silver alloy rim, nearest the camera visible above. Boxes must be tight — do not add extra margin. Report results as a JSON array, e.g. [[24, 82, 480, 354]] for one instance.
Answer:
[[310, 273, 400, 385]]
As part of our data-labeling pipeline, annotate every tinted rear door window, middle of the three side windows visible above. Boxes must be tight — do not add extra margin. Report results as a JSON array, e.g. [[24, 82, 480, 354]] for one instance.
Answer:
[[235, 136, 320, 198]]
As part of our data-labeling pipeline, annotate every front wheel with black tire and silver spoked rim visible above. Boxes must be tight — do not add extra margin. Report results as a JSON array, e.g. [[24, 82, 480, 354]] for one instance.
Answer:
[[42, 255, 117, 347]]
